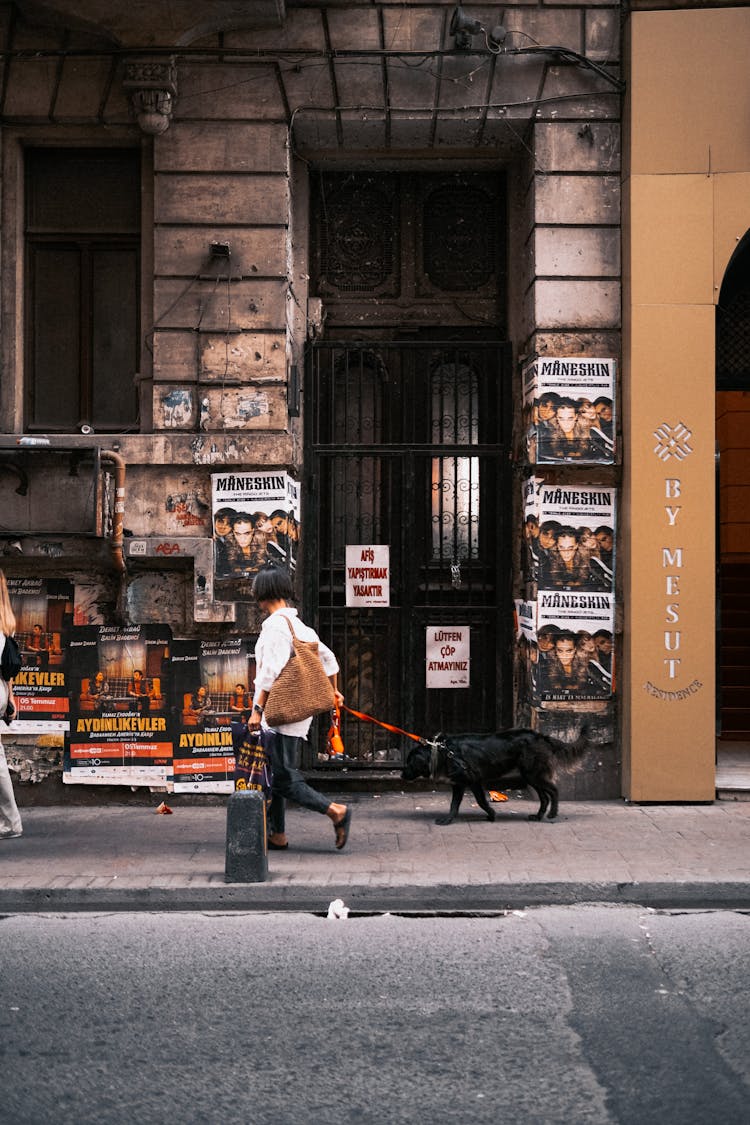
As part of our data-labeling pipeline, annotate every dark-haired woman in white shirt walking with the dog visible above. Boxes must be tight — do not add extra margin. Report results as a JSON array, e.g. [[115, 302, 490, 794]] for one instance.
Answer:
[[247, 567, 352, 851]]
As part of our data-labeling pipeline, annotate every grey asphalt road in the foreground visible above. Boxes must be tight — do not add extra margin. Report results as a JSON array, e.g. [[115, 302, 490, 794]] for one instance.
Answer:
[[0, 907, 750, 1125]]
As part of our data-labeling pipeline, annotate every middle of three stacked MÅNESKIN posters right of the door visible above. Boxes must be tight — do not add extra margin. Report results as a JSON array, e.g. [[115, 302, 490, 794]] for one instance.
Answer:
[[523, 477, 616, 591]]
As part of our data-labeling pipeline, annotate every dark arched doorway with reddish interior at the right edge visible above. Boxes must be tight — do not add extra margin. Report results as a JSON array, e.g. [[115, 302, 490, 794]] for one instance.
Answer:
[[716, 232, 750, 790]]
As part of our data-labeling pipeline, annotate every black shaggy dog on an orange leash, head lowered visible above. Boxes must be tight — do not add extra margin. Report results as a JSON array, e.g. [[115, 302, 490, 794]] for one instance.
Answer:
[[401, 725, 588, 825]]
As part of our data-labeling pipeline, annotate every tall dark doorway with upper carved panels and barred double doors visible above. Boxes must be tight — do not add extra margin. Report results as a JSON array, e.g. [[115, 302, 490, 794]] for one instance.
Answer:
[[305, 171, 513, 766]]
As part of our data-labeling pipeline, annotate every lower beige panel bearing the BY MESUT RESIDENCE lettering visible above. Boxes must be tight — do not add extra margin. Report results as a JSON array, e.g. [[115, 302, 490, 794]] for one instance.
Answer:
[[623, 306, 715, 801]]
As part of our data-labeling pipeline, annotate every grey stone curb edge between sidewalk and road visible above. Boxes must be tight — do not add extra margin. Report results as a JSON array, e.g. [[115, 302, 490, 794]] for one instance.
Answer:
[[0, 882, 750, 915]]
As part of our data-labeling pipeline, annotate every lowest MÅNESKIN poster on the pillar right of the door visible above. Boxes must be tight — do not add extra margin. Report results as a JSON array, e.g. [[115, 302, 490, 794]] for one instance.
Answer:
[[516, 593, 615, 703]]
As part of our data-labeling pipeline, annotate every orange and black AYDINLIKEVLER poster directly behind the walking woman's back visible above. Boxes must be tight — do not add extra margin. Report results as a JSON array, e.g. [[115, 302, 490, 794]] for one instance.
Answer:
[[172, 637, 255, 793]]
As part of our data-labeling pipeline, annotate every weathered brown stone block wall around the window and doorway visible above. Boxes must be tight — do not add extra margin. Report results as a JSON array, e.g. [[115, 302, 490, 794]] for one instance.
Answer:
[[0, 0, 621, 792]]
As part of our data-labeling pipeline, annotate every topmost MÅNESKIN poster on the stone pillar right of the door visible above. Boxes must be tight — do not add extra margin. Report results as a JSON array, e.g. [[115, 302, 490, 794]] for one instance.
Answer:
[[522, 356, 616, 465]]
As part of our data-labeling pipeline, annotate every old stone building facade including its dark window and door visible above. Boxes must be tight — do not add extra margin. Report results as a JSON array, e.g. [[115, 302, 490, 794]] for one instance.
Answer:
[[0, 0, 624, 798]]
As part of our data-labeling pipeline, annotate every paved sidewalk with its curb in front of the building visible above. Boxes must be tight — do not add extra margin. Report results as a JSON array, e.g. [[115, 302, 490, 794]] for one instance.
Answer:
[[0, 790, 750, 914]]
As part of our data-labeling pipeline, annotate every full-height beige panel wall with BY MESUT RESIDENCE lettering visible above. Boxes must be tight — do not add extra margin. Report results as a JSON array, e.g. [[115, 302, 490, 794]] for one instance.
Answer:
[[623, 8, 750, 801]]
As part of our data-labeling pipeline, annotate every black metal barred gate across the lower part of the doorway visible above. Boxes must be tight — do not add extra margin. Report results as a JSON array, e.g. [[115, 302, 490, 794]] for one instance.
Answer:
[[305, 340, 512, 767]]
